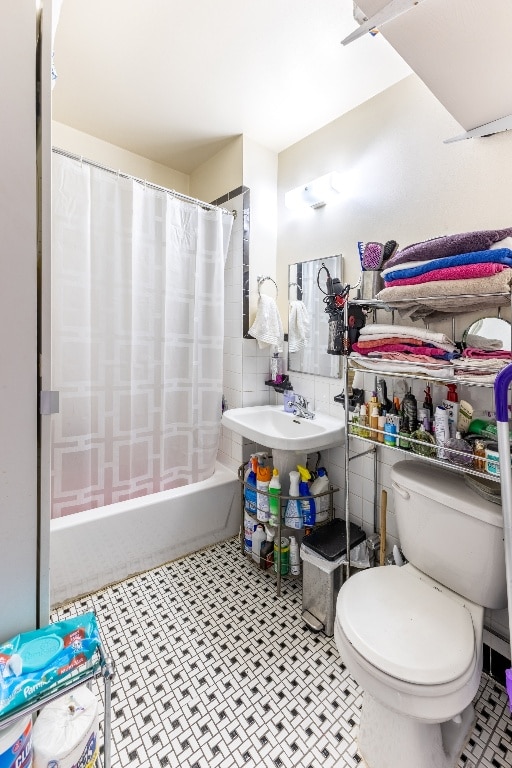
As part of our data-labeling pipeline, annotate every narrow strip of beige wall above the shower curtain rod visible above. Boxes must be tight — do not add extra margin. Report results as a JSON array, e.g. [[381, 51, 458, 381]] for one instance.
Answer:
[[52, 120, 190, 195]]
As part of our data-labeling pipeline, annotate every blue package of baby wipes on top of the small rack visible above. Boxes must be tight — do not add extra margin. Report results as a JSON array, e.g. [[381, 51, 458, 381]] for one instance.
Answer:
[[0, 611, 101, 717]]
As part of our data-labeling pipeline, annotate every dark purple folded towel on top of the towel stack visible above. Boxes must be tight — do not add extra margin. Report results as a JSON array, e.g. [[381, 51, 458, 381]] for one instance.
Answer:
[[384, 228, 512, 269]]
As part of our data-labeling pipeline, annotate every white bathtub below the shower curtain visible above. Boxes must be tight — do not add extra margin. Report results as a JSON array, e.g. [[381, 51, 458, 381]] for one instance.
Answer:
[[50, 462, 240, 607]]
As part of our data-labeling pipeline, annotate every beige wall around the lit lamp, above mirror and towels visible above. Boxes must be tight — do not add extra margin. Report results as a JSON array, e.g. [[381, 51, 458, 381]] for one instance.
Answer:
[[278, 75, 512, 292]]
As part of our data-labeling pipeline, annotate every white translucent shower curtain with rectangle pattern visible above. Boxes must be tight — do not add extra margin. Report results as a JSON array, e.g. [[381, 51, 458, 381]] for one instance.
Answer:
[[51, 152, 233, 517]]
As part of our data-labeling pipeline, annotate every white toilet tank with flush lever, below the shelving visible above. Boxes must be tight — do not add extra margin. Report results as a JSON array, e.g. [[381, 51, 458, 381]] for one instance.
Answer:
[[391, 461, 507, 608]]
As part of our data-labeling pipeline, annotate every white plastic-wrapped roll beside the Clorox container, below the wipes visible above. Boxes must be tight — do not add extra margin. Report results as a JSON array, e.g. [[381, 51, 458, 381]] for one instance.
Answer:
[[32, 685, 99, 768]]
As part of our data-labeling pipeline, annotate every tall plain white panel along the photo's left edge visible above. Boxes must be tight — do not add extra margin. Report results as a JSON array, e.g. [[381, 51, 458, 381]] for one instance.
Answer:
[[0, 0, 38, 640]]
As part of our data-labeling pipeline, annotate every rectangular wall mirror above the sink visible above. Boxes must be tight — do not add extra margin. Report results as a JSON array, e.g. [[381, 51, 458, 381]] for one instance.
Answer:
[[288, 255, 343, 378]]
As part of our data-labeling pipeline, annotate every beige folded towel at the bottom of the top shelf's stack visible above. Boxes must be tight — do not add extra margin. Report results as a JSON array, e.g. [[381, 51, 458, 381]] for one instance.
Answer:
[[376, 268, 512, 320]]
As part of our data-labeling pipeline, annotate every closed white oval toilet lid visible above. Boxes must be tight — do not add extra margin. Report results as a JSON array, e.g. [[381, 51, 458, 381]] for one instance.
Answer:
[[336, 566, 475, 685]]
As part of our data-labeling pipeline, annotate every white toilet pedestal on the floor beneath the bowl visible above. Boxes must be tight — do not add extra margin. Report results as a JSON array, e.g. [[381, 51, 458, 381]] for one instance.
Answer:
[[358, 691, 475, 768]]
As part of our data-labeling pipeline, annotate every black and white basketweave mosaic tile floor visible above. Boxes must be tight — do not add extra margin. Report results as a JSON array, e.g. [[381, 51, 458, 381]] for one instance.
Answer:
[[52, 539, 512, 768]]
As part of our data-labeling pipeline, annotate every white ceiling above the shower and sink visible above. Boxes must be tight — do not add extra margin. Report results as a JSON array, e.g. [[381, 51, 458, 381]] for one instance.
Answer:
[[53, 0, 411, 173]]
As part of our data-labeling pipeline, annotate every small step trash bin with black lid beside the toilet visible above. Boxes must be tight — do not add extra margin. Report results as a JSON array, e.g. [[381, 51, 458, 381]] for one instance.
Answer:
[[300, 518, 366, 637]]
